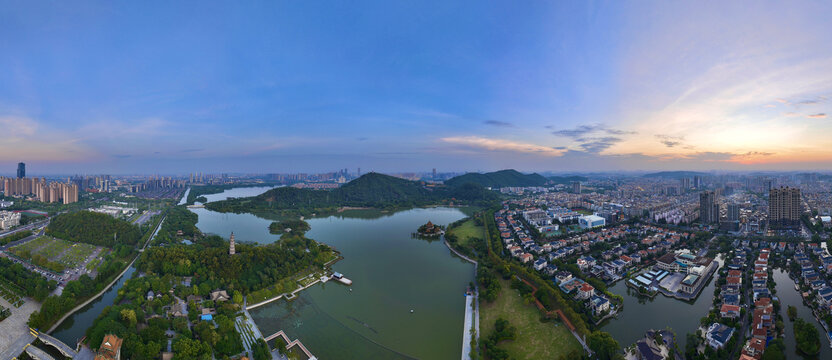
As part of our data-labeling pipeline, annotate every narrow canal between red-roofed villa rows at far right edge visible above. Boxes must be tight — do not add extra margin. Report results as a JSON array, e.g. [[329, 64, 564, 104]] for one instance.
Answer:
[[773, 269, 832, 359]]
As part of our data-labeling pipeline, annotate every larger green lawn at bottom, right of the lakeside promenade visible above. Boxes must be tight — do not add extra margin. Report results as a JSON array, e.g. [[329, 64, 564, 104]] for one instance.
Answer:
[[480, 279, 582, 359]]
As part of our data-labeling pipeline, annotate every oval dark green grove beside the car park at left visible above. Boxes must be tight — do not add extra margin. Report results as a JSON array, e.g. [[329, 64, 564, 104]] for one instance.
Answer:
[[46, 211, 142, 248]]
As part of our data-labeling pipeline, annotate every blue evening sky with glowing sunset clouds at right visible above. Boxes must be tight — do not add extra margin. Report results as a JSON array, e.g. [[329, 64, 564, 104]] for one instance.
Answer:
[[0, 0, 832, 174]]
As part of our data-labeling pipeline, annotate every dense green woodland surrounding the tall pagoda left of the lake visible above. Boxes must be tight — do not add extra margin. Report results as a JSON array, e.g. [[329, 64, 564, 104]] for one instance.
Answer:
[[136, 235, 333, 293]]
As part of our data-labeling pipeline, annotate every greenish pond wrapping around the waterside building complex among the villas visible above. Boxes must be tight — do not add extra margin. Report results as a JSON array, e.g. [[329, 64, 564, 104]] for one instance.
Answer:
[[601, 255, 722, 353]]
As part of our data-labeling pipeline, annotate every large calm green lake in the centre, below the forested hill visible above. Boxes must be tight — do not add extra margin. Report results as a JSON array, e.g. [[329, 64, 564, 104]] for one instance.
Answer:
[[247, 208, 474, 359]]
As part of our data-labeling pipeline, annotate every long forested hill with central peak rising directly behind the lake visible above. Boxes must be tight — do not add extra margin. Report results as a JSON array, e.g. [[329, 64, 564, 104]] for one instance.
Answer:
[[206, 173, 497, 214]]
